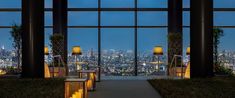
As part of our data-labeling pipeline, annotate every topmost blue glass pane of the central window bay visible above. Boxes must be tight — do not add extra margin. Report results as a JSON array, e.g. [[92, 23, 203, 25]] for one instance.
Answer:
[[101, 0, 135, 8]]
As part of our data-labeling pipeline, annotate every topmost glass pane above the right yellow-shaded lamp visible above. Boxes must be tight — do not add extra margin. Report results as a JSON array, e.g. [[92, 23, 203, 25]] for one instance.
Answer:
[[138, 0, 168, 8]]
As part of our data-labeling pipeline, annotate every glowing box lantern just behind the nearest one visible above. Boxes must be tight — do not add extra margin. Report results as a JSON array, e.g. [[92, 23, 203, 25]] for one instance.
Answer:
[[78, 70, 96, 91]]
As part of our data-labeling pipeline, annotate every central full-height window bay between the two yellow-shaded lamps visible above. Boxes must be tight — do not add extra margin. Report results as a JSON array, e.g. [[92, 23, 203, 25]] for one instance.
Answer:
[[100, 8, 135, 76]]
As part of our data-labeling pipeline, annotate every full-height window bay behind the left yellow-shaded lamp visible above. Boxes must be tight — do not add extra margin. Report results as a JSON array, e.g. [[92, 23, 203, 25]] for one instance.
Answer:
[[68, 0, 99, 76]]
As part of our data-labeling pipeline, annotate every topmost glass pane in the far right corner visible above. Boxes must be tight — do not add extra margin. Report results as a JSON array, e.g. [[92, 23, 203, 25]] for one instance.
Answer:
[[214, 0, 235, 8]]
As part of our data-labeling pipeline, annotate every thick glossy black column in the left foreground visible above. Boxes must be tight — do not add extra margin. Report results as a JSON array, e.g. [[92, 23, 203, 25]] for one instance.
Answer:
[[22, 0, 44, 78]]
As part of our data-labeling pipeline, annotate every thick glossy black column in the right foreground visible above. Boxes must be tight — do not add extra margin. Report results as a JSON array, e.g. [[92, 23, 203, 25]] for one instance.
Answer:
[[190, 0, 213, 78]]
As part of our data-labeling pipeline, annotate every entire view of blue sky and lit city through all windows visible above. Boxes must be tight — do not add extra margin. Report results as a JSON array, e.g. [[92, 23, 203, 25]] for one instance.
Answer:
[[0, 0, 235, 76]]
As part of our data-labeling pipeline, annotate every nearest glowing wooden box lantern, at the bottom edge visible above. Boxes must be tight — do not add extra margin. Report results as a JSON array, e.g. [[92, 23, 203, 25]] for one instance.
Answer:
[[65, 79, 87, 98]]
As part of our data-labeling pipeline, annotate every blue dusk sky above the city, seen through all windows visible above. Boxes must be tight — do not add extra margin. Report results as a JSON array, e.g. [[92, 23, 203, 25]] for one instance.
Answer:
[[0, 0, 235, 51]]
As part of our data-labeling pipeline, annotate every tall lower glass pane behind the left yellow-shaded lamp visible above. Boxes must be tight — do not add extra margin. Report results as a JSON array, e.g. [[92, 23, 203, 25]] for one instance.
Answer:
[[68, 28, 98, 72]]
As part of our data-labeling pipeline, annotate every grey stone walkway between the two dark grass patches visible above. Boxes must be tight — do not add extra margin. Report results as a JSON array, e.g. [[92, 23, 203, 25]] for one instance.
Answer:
[[88, 80, 161, 98]]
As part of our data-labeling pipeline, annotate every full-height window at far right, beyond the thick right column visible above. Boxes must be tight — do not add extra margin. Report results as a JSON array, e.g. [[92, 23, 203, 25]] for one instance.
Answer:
[[214, 0, 235, 72]]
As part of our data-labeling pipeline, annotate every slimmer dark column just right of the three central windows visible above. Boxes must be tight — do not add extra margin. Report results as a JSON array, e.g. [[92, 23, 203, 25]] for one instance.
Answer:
[[168, 0, 183, 74]]
